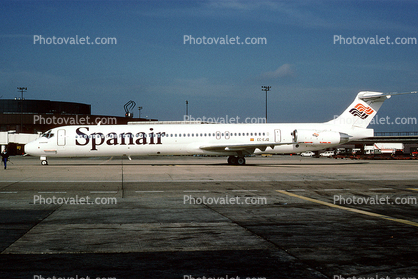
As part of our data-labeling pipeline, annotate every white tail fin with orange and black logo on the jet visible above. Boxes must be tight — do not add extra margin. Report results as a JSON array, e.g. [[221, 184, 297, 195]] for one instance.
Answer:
[[327, 91, 392, 128]]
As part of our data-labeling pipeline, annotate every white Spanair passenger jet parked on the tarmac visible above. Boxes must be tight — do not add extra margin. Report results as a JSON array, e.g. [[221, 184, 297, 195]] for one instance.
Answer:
[[25, 91, 417, 165]]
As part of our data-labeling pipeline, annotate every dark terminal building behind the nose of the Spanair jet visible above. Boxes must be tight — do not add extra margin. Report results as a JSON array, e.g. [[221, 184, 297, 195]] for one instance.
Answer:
[[0, 98, 157, 155]]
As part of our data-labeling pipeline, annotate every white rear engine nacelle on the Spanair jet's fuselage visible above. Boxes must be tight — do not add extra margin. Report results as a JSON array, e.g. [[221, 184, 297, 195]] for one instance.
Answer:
[[292, 130, 350, 146]]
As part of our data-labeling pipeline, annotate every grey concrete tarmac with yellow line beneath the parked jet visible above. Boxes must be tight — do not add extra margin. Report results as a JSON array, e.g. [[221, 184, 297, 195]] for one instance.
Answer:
[[0, 156, 418, 279]]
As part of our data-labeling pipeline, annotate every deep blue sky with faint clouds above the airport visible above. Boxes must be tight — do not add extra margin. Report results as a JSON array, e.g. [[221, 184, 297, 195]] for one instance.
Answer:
[[0, 0, 418, 131]]
